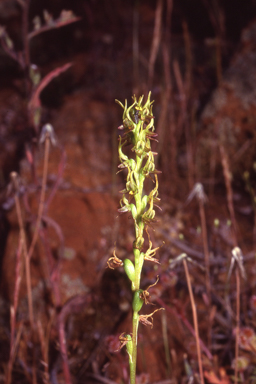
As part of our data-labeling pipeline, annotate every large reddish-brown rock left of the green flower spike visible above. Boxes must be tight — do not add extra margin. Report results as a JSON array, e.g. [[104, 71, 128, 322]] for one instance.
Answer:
[[2, 92, 118, 312]]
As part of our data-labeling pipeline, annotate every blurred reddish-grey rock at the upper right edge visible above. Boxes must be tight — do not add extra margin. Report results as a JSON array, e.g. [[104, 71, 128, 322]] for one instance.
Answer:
[[197, 21, 256, 175]]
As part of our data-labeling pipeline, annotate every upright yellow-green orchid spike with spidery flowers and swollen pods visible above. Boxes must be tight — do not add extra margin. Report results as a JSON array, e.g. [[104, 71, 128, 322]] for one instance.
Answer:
[[113, 94, 161, 384]]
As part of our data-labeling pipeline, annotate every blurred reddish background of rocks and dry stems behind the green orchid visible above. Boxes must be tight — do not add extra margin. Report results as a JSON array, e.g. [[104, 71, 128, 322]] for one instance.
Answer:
[[0, 0, 256, 384]]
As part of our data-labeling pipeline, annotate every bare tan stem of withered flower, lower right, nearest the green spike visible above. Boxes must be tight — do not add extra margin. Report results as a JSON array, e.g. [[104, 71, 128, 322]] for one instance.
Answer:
[[183, 259, 204, 384]]
